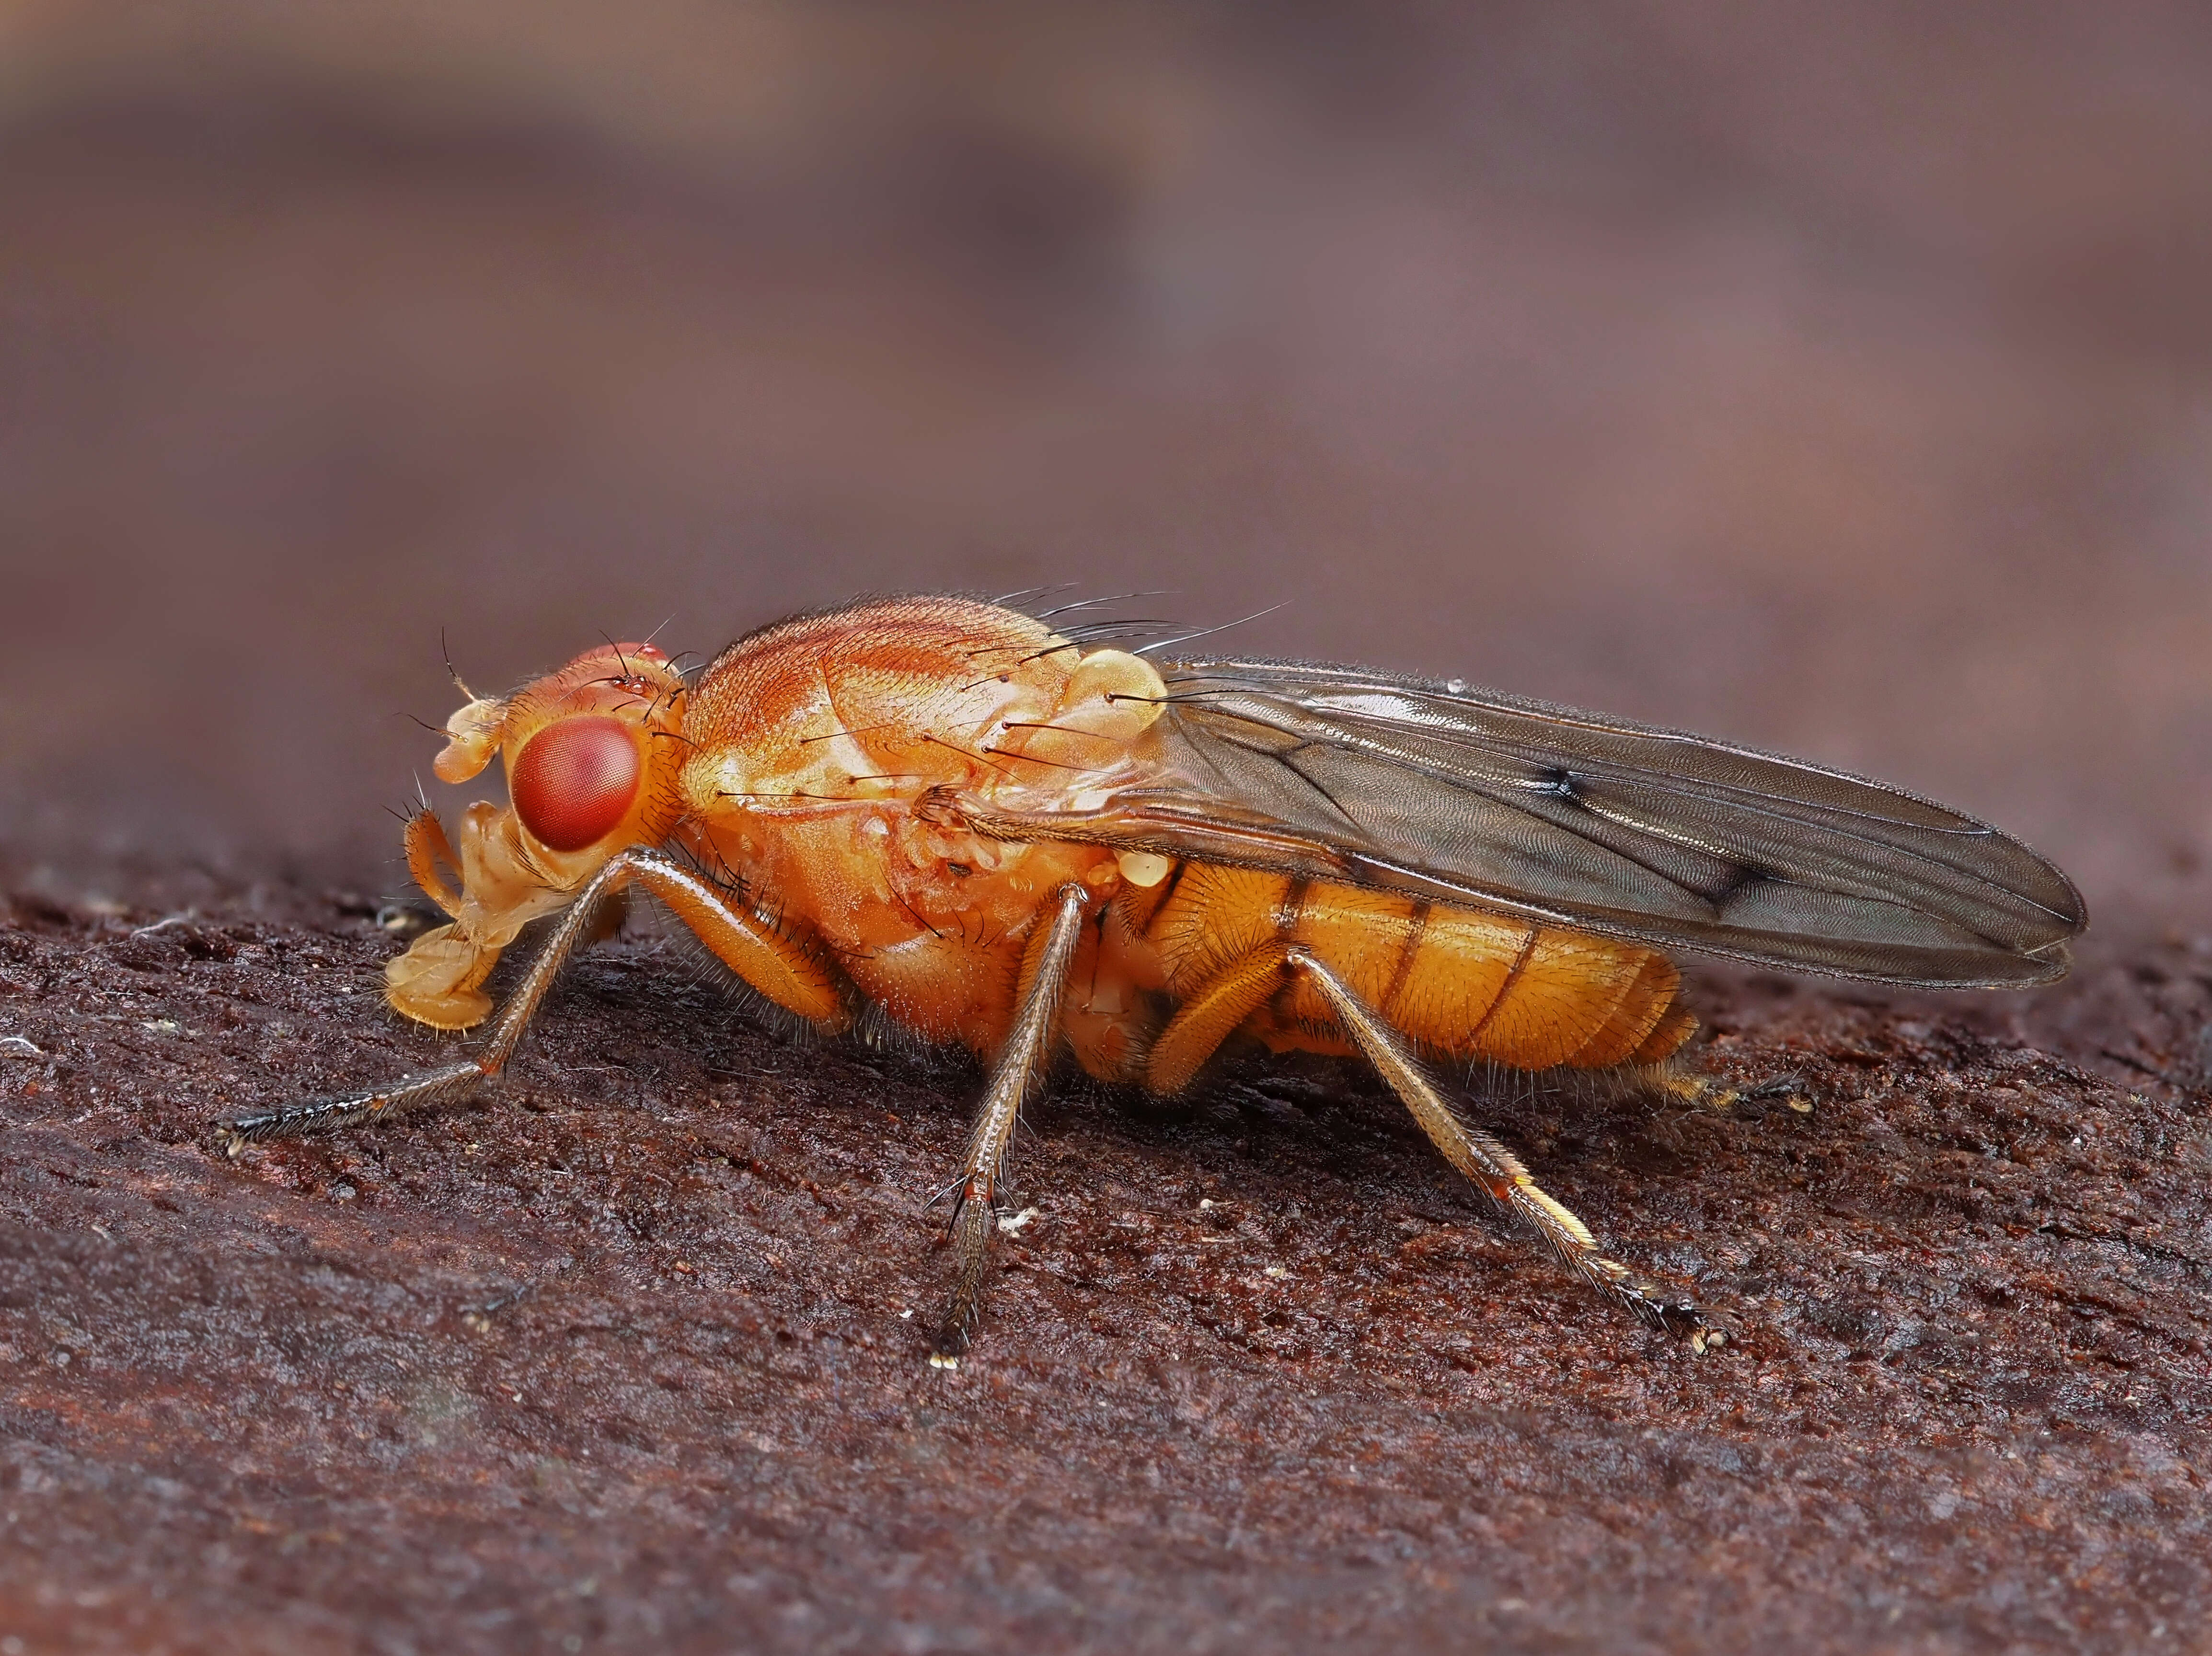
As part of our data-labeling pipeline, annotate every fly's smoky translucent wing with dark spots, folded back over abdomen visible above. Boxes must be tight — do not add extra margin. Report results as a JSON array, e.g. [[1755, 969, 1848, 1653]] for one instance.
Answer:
[[995, 661, 2086, 989]]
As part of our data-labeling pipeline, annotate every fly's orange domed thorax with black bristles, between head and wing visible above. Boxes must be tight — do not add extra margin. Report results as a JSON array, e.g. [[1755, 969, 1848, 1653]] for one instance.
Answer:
[[655, 599, 1166, 1050]]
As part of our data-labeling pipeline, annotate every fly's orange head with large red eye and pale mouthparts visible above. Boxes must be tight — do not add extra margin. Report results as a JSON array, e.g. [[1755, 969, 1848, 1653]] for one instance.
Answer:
[[385, 644, 686, 1028]]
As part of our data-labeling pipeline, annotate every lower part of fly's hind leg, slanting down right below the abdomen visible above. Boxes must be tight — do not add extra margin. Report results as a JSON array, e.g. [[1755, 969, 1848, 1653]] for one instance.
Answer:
[[1285, 948, 1719, 1351]]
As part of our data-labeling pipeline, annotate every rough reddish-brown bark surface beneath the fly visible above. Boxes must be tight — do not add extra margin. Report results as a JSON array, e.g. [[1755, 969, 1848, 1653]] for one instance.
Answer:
[[0, 878, 2212, 1652]]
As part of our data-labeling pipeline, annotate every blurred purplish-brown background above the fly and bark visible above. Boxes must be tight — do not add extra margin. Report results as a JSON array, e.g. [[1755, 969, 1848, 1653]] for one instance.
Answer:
[[0, 0, 2212, 922]]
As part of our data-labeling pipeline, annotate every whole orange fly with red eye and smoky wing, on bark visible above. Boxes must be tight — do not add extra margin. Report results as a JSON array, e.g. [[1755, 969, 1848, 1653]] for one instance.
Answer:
[[221, 597, 2084, 1364]]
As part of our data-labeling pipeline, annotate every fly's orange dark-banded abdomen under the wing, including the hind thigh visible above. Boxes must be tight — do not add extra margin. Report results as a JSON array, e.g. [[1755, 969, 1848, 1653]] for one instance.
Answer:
[[1146, 862, 1696, 1086]]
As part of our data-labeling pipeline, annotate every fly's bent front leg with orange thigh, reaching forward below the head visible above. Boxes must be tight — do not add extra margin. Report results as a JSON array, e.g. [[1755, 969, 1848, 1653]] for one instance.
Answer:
[[215, 847, 845, 1156]]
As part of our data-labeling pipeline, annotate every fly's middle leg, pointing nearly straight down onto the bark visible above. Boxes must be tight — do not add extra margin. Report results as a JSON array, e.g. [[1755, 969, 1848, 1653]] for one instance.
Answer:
[[929, 885, 1091, 1368]]
